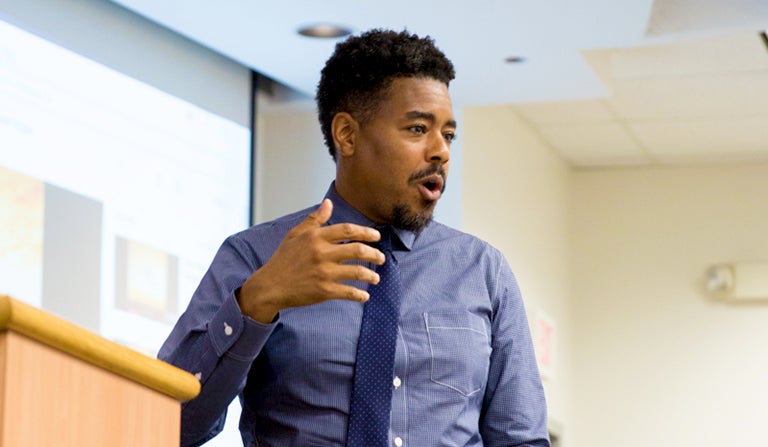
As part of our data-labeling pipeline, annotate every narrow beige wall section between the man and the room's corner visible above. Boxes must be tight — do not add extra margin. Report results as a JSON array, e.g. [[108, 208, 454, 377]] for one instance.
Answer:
[[462, 106, 573, 446]]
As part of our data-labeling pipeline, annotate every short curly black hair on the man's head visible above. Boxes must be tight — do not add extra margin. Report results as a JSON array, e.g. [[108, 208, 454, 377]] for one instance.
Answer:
[[315, 29, 456, 160]]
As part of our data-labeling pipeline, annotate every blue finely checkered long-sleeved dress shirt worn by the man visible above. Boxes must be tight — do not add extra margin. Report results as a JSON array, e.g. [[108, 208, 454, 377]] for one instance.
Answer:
[[159, 185, 549, 447]]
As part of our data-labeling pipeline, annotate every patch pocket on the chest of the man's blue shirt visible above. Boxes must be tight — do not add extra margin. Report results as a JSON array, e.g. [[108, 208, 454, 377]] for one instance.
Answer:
[[424, 311, 491, 396]]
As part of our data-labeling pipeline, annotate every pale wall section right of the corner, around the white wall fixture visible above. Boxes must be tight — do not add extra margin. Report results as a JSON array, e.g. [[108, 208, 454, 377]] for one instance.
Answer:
[[568, 164, 768, 447]]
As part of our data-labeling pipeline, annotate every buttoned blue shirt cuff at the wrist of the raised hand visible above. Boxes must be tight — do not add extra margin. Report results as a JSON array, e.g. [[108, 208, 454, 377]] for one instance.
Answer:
[[208, 294, 279, 361]]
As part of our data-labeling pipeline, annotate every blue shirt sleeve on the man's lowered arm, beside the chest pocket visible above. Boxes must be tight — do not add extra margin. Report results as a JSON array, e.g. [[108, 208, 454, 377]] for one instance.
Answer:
[[480, 254, 550, 447]]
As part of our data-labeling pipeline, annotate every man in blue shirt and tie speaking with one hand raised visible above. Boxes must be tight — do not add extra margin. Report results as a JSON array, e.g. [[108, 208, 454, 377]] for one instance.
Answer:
[[160, 30, 549, 447]]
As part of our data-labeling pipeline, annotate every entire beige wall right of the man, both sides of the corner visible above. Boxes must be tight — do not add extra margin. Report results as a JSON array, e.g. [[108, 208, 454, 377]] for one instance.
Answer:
[[462, 106, 768, 447]]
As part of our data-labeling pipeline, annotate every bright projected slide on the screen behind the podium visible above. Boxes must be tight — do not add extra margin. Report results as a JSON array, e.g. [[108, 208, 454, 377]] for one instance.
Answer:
[[0, 21, 251, 354]]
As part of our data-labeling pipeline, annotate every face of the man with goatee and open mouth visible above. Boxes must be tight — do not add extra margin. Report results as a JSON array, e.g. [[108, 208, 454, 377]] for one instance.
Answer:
[[343, 78, 456, 231]]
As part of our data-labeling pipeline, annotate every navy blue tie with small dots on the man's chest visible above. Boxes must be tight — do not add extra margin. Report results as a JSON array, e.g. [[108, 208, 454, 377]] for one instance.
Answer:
[[347, 228, 402, 447]]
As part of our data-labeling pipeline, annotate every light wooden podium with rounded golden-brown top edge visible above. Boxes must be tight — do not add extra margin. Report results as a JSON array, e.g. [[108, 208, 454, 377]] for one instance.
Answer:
[[0, 295, 200, 447]]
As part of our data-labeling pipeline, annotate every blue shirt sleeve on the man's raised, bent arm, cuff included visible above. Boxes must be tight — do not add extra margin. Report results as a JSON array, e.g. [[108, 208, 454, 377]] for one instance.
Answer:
[[158, 236, 277, 446]]
